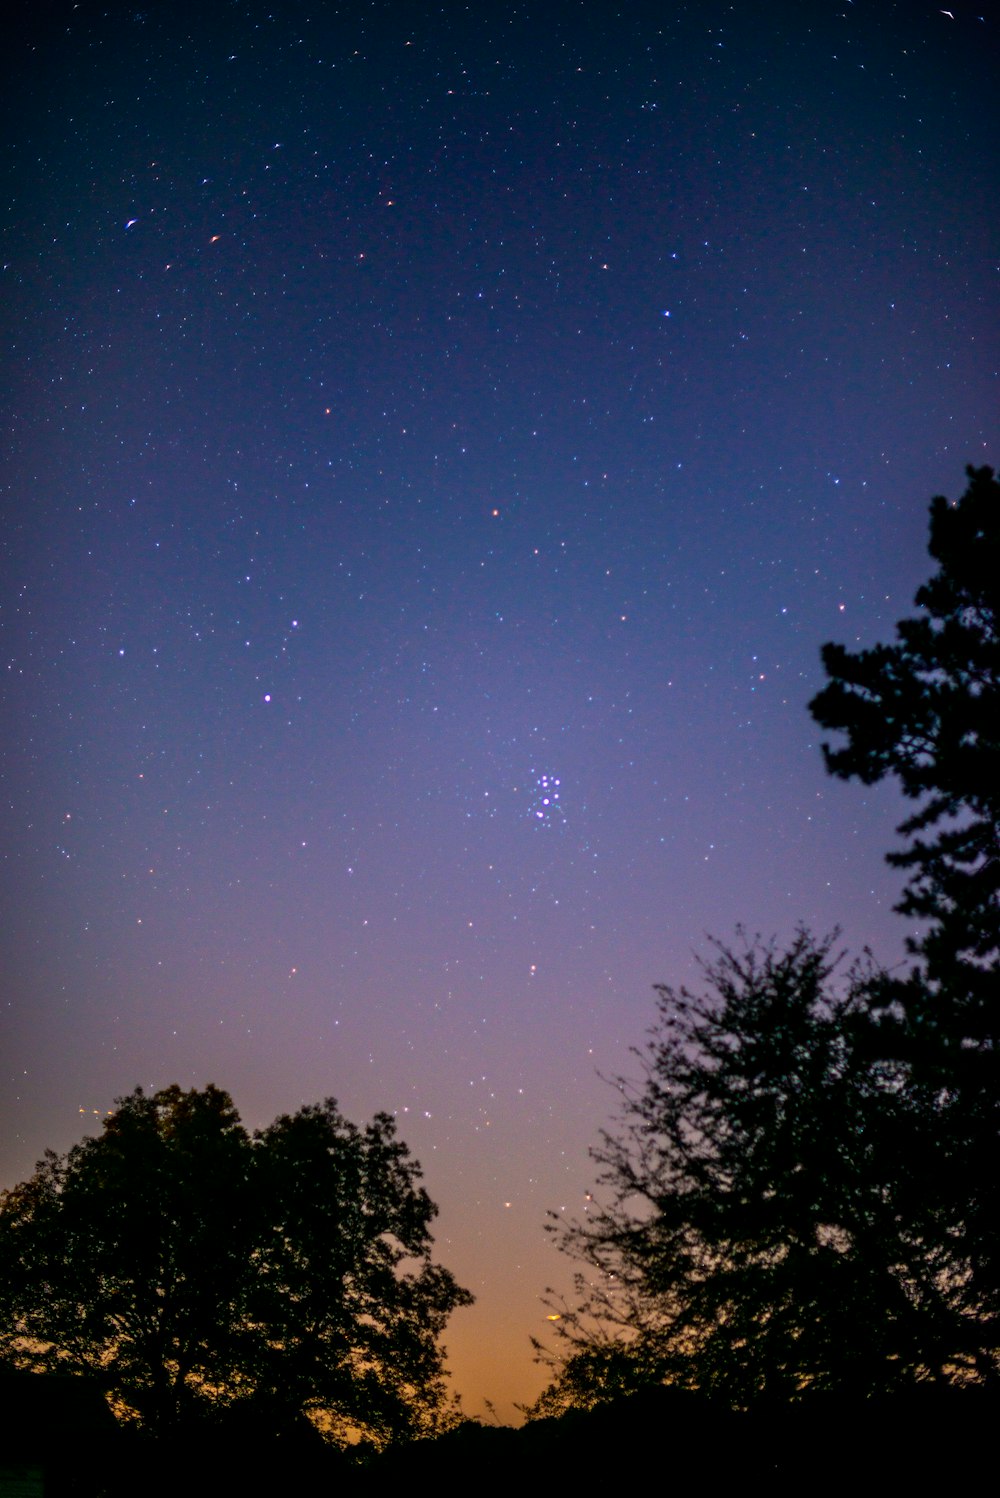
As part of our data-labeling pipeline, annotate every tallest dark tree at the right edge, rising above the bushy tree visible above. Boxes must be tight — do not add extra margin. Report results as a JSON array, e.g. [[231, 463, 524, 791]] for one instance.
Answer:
[[810, 467, 1000, 1360]]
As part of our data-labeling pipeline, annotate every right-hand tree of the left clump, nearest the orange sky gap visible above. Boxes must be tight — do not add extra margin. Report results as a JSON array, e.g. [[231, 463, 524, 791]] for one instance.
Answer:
[[250, 1101, 472, 1440]]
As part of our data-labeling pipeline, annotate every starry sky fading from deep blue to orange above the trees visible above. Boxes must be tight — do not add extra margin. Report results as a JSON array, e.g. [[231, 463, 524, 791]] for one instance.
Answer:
[[0, 0, 1000, 1419]]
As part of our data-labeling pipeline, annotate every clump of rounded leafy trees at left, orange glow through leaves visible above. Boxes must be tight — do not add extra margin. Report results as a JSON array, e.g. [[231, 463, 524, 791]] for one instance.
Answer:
[[0, 1086, 472, 1443]]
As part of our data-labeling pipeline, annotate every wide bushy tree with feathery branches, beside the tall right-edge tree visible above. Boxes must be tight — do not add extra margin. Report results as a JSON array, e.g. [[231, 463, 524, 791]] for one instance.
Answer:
[[534, 930, 993, 1414]]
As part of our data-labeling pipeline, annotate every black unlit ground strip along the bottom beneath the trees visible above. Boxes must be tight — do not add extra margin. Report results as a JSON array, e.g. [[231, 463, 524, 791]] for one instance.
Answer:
[[0, 1380, 1000, 1498]]
